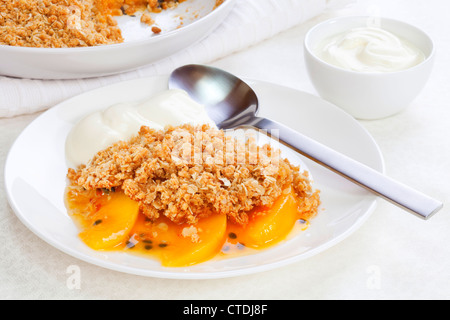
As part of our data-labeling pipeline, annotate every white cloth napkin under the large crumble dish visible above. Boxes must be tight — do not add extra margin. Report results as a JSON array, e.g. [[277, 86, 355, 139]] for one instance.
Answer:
[[0, 0, 342, 117]]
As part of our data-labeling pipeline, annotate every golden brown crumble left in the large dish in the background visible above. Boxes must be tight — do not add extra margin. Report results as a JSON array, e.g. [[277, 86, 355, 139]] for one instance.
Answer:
[[0, 0, 123, 48]]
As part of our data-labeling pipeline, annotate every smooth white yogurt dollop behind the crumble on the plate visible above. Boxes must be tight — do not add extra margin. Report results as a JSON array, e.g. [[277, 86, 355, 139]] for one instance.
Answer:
[[66, 89, 215, 168]]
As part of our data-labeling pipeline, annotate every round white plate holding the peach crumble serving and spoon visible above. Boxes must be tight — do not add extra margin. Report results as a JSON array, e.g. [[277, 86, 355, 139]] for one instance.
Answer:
[[5, 77, 384, 279]]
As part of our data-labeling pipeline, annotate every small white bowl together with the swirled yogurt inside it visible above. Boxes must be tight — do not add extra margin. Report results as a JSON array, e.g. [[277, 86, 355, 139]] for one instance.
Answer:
[[304, 16, 435, 120]]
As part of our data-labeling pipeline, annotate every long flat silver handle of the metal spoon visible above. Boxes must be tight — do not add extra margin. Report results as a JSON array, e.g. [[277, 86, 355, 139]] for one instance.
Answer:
[[250, 117, 443, 220]]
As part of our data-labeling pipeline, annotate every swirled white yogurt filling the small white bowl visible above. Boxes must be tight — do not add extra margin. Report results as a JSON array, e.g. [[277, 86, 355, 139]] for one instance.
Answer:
[[315, 27, 425, 72]]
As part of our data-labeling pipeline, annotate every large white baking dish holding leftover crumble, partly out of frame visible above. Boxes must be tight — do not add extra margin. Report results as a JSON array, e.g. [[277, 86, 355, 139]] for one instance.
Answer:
[[0, 0, 236, 79]]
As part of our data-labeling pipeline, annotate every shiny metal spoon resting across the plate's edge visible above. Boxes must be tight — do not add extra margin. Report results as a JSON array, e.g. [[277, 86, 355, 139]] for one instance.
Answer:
[[169, 65, 443, 220]]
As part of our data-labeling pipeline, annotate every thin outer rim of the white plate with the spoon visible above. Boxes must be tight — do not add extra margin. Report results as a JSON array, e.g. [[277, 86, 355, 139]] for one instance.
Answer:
[[3, 75, 386, 280]]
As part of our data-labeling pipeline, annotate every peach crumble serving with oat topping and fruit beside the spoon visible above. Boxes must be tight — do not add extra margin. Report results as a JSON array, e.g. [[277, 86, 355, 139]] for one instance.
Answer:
[[65, 124, 320, 267]]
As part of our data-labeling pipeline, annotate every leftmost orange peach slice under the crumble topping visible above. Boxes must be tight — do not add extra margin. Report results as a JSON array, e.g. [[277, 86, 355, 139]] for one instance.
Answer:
[[79, 192, 139, 250]]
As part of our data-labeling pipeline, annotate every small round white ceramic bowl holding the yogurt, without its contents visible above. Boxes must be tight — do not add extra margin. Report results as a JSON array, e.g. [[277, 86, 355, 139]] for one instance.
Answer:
[[304, 16, 435, 120]]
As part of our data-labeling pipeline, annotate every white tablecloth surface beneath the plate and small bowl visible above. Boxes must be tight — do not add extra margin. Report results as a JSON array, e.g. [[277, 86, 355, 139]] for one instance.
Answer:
[[0, 0, 450, 299]]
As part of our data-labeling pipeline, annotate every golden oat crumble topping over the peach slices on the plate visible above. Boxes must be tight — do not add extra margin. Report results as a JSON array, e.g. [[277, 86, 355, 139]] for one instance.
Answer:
[[68, 125, 320, 224]]
